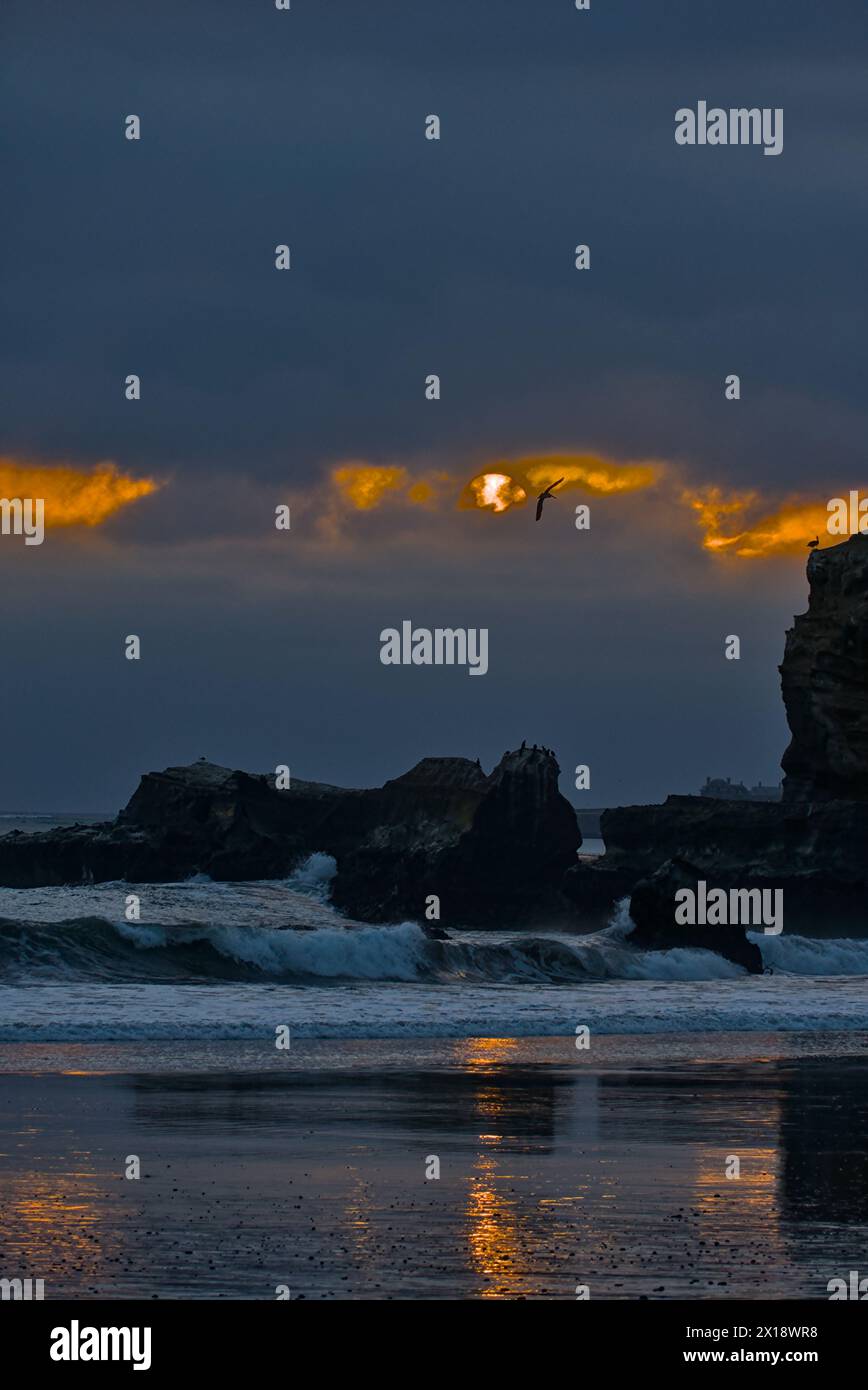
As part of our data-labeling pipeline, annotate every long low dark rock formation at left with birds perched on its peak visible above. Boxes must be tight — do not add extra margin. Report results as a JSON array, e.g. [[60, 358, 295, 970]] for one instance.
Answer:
[[0, 748, 581, 924]]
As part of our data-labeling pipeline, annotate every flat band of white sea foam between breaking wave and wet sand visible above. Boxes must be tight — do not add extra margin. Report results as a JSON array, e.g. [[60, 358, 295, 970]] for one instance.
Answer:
[[0, 976, 868, 1055]]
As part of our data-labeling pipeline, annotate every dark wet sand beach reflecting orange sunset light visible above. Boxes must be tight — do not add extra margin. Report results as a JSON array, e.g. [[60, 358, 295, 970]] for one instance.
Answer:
[[0, 1036, 868, 1300]]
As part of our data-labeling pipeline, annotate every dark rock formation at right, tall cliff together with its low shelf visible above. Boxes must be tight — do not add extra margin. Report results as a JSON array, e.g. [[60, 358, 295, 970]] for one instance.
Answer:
[[603, 535, 868, 967]]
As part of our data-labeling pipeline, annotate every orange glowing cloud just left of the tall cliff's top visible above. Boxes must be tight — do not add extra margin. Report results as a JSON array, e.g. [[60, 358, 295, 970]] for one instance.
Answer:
[[682, 488, 829, 559]]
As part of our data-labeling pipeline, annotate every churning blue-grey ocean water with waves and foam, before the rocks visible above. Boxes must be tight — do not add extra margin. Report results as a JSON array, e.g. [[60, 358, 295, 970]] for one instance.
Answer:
[[0, 855, 868, 1049]]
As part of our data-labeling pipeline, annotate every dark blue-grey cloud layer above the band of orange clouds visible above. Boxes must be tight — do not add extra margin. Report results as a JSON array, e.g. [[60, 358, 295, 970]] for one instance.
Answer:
[[6, 3, 868, 482]]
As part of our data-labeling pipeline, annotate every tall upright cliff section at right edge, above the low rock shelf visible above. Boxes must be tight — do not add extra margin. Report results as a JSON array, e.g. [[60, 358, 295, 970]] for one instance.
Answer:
[[780, 535, 868, 802]]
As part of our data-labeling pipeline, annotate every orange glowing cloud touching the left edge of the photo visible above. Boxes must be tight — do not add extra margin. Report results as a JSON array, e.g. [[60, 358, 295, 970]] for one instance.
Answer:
[[0, 457, 160, 530]]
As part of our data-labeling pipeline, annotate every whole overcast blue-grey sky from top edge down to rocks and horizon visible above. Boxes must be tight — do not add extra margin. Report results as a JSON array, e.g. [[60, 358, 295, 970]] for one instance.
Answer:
[[0, 0, 868, 810]]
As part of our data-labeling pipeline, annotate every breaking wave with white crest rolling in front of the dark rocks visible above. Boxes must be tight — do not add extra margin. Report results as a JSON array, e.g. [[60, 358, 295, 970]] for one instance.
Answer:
[[0, 911, 868, 986]]
